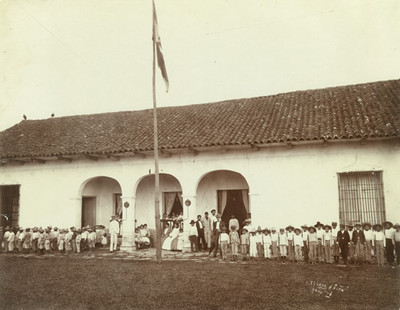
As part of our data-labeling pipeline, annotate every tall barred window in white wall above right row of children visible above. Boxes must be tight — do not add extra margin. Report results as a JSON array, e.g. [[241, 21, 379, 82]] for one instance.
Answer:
[[338, 171, 386, 225]]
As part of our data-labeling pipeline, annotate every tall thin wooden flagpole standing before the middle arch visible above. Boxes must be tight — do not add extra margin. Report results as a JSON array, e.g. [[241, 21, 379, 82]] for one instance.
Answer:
[[152, 2, 161, 264]]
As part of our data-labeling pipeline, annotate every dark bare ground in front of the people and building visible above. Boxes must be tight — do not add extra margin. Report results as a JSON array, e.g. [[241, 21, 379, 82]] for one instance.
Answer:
[[0, 249, 400, 309]]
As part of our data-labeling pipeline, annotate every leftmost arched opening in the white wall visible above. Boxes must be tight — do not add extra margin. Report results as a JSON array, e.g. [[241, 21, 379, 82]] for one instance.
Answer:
[[81, 177, 122, 227]]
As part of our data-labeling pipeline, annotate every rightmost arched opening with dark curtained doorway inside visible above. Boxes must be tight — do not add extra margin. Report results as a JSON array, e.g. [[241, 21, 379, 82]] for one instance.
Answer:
[[196, 170, 250, 227]]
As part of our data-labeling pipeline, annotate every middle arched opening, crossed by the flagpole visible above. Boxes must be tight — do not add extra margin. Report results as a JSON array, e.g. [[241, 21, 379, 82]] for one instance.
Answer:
[[135, 174, 183, 229]]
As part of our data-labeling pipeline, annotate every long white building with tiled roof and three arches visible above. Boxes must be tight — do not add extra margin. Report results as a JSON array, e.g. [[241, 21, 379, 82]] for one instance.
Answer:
[[0, 80, 400, 249]]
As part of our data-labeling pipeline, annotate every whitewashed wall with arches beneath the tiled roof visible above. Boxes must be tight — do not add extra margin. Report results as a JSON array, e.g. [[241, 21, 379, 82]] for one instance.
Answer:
[[0, 140, 400, 236]]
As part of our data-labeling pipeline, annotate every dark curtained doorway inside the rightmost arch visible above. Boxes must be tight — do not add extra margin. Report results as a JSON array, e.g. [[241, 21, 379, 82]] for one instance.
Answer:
[[218, 190, 249, 229]]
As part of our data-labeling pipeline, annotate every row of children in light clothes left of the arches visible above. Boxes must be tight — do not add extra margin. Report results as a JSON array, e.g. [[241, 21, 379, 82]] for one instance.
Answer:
[[2, 225, 108, 255]]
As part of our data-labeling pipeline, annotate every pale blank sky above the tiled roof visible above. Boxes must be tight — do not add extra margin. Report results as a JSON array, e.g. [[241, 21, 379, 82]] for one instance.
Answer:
[[0, 0, 400, 130]]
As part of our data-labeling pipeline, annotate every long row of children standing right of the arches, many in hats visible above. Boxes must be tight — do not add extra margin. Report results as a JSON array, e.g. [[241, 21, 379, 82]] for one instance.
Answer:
[[214, 221, 400, 266]]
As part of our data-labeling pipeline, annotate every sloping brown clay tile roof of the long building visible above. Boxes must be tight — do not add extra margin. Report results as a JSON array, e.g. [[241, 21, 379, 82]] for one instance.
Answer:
[[0, 80, 400, 159]]
